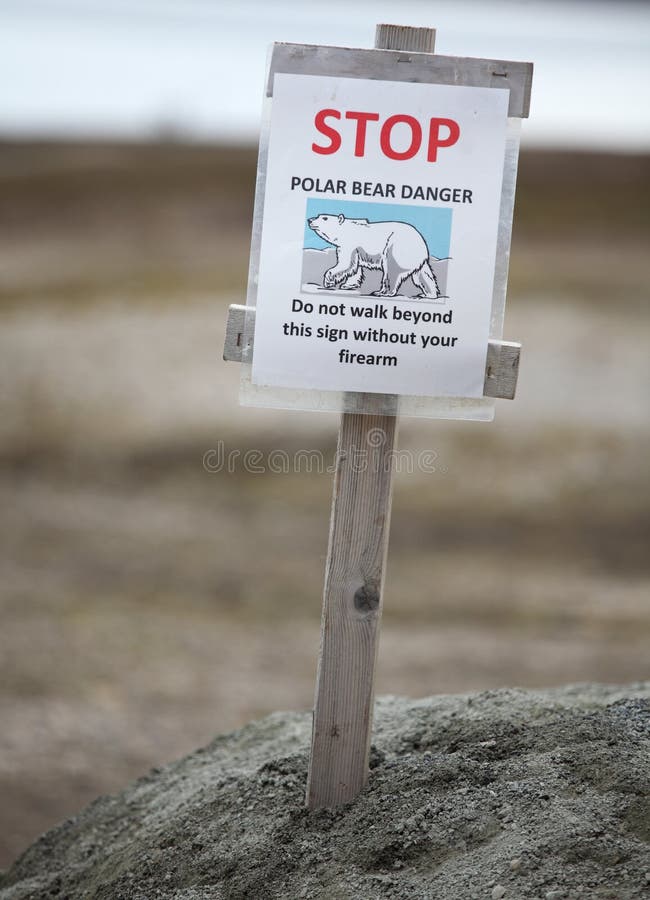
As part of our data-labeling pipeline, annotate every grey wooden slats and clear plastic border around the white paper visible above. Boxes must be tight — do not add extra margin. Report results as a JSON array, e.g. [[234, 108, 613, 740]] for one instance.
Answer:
[[235, 26, 532, 421]]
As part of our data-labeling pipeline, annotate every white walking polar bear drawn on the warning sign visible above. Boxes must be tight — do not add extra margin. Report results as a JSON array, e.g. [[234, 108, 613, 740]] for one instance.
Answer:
[[307, 213, 440, 299]]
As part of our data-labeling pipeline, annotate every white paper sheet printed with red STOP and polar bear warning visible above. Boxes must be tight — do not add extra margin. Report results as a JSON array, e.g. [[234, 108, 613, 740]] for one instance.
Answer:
[[252, 74, 509, 397]]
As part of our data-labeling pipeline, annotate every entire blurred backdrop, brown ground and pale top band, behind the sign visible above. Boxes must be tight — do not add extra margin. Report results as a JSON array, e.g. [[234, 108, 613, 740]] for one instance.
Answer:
[[0, 0, 650, 867]]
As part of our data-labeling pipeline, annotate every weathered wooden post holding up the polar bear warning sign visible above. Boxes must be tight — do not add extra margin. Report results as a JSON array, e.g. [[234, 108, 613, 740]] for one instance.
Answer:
[[306, 19, 436, 809]]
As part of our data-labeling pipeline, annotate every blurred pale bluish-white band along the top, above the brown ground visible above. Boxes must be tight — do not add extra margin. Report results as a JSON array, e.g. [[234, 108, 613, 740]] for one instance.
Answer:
[[0, 0, 650, 151]]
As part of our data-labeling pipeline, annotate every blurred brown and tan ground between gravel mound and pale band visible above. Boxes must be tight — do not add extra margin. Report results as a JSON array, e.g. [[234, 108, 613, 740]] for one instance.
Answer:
[[0, 147, 650, 867]]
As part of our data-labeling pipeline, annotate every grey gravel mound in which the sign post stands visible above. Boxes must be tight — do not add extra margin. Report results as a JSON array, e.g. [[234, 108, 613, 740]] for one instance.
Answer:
[[0, 683, 650, 900]]
